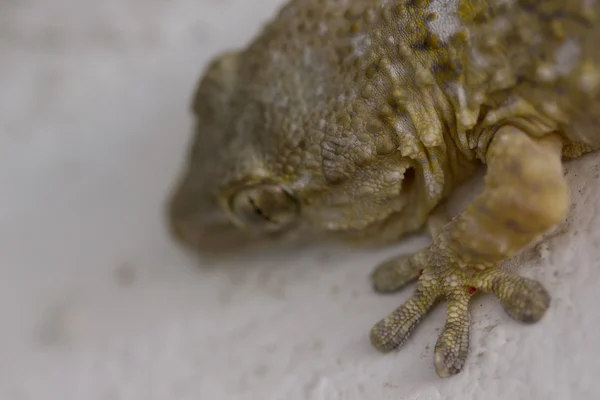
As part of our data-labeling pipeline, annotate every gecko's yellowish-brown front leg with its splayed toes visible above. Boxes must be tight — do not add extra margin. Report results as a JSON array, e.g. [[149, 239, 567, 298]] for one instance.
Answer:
[[371, 125, 569, 377]]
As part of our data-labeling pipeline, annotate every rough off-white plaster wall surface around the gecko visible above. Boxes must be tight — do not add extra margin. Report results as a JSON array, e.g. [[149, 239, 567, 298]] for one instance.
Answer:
[[0, 0, 600, 400]]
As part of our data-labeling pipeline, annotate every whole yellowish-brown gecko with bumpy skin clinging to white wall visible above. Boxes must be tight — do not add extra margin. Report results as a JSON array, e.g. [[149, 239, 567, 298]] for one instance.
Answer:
[[169, 0, 600, 377]]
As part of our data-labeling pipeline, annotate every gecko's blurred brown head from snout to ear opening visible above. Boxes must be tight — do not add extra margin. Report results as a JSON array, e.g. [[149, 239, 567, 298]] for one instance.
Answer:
[[169, 38, 439, 254]]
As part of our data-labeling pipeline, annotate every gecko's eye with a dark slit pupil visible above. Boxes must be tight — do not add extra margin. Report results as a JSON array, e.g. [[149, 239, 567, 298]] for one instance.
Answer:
[[230, 185, 300, 231]]
